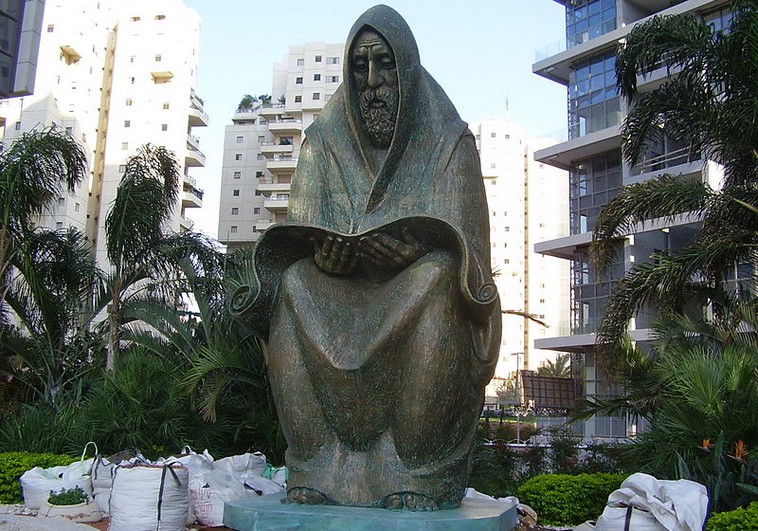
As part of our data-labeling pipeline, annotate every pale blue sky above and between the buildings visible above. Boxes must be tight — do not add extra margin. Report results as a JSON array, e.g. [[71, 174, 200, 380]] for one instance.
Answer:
[[184, 0, 566, 237]]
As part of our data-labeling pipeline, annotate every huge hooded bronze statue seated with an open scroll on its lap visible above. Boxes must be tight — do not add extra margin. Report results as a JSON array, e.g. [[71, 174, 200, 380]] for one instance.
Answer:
[[233, 5, 501, 510]]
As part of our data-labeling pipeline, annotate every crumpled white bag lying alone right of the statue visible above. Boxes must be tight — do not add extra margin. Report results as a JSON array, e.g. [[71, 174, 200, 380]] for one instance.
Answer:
[[595, 473, 708, 531]]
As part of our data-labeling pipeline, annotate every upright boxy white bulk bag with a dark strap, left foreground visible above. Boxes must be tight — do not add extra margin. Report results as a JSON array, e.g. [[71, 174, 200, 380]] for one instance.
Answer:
[[108, 463, 190, 531]]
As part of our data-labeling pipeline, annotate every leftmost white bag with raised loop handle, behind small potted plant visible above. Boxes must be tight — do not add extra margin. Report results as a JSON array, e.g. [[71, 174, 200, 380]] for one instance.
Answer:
[[19, 442, 97, 509]]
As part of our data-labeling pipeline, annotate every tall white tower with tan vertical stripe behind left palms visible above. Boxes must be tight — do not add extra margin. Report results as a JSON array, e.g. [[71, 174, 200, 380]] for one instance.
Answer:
[[0, 0, 208, 265]]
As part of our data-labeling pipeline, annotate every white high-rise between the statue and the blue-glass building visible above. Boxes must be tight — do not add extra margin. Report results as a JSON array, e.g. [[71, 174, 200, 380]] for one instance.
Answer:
[[471, 118, 569, 404]]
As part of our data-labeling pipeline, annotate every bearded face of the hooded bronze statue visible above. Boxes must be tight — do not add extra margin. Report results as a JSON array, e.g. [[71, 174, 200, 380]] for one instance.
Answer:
[[350, 30, 399, 148]]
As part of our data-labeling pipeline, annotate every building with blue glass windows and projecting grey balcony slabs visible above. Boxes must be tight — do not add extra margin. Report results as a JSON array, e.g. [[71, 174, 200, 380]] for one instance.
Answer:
[[532, 0, 729, 437]]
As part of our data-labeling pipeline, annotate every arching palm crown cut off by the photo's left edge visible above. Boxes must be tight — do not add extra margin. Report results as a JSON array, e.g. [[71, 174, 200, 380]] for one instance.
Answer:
[[0, 128, 87, 330]]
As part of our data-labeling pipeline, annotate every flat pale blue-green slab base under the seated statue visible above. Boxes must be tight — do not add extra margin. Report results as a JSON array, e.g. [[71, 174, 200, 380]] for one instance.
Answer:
[[224, 493, 518, 531]]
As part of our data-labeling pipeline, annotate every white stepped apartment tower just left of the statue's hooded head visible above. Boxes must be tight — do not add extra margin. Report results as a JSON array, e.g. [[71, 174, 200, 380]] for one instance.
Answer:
[[218, 42, 345, 249]]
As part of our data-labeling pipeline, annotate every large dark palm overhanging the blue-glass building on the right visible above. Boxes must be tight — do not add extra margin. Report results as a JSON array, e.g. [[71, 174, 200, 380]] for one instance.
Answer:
[[590, 0, 758, 353]]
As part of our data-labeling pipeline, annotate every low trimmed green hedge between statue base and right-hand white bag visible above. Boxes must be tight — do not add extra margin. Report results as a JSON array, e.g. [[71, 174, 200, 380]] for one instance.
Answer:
[[516, 474, 626, 526]]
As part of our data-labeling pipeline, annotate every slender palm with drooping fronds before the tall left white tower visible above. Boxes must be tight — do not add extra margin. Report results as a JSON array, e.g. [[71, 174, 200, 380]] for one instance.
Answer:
[[105, 144, 181, 371]]
